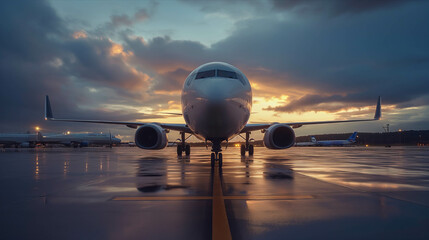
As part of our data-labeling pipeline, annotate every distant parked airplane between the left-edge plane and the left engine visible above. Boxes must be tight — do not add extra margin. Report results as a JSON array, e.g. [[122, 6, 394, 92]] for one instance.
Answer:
[[40, 133, 121, 147]]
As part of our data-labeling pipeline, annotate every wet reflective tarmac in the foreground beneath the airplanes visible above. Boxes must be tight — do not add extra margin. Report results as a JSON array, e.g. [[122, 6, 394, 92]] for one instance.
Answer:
[[0, 147, 429, 239]]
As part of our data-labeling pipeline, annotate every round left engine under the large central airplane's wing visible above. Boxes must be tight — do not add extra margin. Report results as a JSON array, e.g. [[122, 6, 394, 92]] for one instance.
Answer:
[[134, 123, 168, 149]]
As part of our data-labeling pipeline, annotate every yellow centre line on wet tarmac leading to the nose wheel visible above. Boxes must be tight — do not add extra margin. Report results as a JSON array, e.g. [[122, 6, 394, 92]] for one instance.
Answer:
[[212, 162, 232, 240]]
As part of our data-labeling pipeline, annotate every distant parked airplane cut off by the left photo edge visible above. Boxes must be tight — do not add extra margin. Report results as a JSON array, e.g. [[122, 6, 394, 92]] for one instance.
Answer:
[[0, 132, 42, 148]]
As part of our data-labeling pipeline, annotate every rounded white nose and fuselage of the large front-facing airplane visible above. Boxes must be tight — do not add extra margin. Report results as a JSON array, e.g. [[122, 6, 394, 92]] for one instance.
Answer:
[[182, 62, 252, 141]]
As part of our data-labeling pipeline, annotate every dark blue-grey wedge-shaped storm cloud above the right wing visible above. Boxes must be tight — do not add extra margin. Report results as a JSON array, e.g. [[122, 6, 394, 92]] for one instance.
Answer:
[[212, 2, 429, 111]]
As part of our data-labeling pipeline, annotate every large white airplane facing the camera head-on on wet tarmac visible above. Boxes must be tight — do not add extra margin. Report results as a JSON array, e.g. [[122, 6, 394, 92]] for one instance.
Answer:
[[45, 62, 381, 167]]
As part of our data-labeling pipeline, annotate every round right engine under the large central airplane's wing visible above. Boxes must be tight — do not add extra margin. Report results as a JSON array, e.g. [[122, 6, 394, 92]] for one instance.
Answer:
[[264, 124, 295, 149]]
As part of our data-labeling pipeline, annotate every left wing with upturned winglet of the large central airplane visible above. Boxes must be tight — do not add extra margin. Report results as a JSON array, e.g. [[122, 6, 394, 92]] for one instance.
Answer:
[[45, 95, 192, 133]]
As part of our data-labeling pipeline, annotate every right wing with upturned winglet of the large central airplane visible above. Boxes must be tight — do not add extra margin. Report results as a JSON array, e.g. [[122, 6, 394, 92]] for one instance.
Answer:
[[241, 97, 381, 133]]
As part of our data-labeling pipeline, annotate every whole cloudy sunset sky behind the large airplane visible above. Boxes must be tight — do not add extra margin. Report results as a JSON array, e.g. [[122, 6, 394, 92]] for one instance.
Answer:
[[0, 0, 429, 140]]
